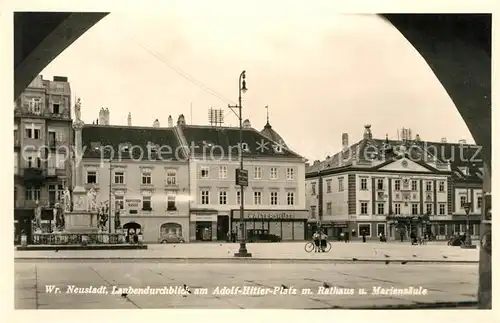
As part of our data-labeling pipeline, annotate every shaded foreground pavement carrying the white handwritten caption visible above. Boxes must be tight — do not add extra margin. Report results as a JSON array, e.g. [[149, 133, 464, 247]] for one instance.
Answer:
[[15, 261, 478, 309]]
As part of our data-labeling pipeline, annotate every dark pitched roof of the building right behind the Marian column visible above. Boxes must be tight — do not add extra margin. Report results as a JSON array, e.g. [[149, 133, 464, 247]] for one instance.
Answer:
[[82, 125, 184, 161]]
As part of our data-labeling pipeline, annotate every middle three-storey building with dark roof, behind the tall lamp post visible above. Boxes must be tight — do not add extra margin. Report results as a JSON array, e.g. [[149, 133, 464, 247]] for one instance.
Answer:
[[177, 116, 308, 240]]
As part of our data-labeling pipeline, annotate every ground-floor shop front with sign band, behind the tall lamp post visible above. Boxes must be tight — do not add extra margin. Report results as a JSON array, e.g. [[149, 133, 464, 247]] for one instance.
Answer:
[[231, 210, 309, 241]]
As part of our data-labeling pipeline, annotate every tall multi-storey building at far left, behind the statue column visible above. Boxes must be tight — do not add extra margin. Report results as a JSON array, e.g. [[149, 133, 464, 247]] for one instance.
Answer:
[[14, 75, 73, 238]]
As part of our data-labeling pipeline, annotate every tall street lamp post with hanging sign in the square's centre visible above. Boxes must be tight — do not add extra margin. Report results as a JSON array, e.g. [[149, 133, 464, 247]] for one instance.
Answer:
[[229, 71, 252, 257]]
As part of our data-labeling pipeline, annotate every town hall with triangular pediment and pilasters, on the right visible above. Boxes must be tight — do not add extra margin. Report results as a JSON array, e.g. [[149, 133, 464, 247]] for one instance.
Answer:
[[306, 126, 480, 239]]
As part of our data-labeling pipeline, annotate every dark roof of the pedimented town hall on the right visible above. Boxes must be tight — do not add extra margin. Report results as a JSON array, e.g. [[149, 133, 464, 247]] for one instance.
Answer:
[[306, 138, 483, 182]]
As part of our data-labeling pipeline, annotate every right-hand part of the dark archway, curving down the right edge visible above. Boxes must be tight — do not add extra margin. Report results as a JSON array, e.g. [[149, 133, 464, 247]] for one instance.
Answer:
[[382, 14, 492, 309]]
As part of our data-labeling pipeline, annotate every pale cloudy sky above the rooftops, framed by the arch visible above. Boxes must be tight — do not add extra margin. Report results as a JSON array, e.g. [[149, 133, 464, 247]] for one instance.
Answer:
[[41, 7, 473, 160]]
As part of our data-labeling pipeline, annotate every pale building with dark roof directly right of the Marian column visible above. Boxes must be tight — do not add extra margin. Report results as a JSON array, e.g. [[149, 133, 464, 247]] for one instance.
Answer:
[[82, 110, 190, 243]]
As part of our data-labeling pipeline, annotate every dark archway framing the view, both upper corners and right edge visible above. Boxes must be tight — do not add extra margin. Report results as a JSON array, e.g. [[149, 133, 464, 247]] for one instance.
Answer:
[[14, 12, 492, 309]]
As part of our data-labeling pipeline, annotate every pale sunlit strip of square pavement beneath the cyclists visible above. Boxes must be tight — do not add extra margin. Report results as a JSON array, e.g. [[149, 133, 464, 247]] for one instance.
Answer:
[[15, 242, 479, 262]]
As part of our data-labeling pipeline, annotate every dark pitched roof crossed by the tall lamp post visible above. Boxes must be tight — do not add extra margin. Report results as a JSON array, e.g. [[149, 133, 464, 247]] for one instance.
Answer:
[[182, 125, 303, 158]]
